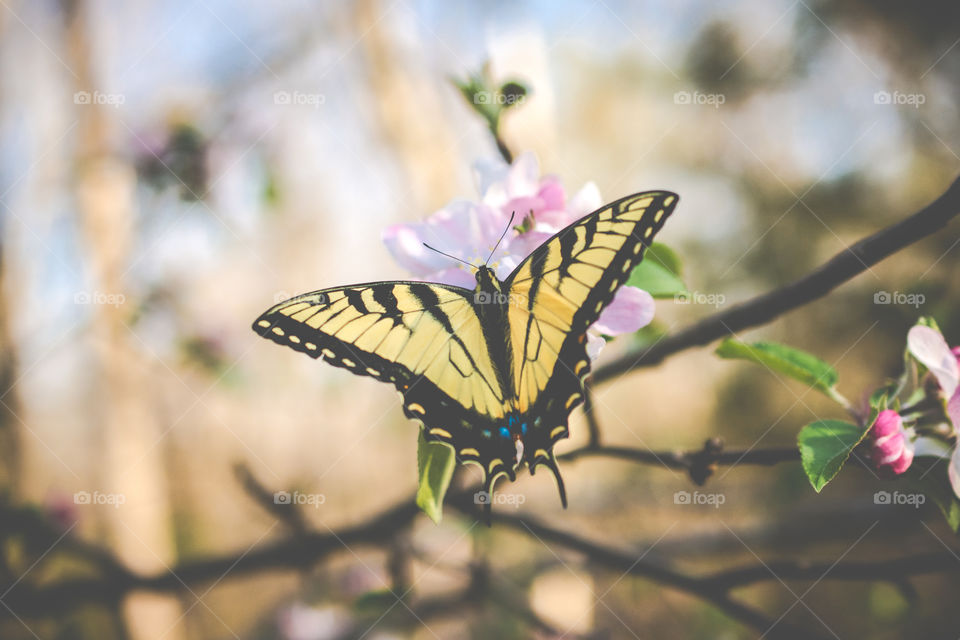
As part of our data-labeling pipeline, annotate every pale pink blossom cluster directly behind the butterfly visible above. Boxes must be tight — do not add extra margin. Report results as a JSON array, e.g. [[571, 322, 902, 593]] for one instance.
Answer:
[[383, 152, 655, 358]]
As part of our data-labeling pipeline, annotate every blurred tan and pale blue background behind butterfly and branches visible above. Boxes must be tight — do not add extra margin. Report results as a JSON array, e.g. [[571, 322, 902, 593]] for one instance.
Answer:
[[0, 0, 960, 640]]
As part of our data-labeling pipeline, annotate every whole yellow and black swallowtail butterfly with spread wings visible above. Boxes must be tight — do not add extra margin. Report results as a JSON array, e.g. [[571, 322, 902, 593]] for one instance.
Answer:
[[253, 191, 678, 507]]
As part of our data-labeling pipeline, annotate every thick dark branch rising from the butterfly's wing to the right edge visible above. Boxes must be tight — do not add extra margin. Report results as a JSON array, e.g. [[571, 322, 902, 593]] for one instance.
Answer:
[[593, 179, 960, 383]]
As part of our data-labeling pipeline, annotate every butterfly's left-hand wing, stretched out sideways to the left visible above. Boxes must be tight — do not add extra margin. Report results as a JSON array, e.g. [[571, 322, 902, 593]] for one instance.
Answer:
[[253, 282, 514, 470]]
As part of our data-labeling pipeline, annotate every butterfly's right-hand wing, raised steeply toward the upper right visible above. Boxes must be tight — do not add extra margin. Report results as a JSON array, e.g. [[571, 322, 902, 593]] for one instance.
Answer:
[[505, 191, 678, 497]]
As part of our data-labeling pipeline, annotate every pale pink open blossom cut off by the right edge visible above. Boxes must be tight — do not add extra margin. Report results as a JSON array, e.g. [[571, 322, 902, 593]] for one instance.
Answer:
[[907, 325, 960, 498]]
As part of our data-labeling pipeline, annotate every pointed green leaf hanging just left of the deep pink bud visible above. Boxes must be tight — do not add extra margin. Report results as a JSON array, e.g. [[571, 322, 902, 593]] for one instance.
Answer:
[[797, 420, 870, 493]]
